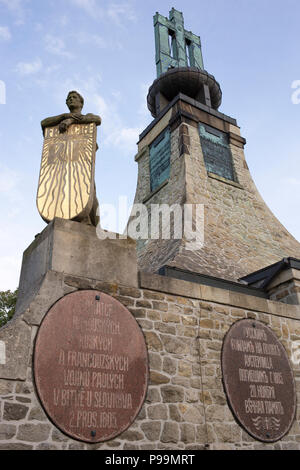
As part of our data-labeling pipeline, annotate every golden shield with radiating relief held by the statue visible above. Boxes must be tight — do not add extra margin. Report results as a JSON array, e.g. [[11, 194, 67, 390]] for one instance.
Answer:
[[37, 123, 97, 222]]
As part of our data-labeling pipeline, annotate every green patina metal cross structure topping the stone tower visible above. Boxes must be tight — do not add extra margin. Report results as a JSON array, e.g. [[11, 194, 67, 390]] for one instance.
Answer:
[[154, 8, 204, 77]]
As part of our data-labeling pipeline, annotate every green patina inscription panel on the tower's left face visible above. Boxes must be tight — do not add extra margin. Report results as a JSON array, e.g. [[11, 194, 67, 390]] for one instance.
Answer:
[[150, 129, 171, 191]]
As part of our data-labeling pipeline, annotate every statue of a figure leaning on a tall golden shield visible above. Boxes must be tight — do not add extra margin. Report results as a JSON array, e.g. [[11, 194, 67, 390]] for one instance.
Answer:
[[37, 91, 101, 225]]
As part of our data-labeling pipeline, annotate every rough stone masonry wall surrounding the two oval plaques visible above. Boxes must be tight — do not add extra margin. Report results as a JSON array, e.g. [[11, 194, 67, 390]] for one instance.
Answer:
[[0, 272, 300, 450]]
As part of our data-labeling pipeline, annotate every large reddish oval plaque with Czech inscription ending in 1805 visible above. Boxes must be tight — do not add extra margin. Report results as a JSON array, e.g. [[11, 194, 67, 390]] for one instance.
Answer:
[[34, 290, 148, 442]]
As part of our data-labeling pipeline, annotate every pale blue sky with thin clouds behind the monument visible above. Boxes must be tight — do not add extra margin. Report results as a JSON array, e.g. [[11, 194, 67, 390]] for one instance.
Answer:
[[0, 0, 300, 290]]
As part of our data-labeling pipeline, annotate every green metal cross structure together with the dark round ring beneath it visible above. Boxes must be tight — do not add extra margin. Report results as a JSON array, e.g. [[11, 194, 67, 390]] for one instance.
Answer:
[[147, 8, 222, 117]]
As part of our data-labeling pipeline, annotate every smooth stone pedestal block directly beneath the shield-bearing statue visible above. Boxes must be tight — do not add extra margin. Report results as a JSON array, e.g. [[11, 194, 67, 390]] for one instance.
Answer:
[[16, 219, 138, 314]]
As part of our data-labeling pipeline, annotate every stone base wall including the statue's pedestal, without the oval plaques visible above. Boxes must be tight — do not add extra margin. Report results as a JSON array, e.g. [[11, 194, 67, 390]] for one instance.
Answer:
[[0, 219, 300, 451]]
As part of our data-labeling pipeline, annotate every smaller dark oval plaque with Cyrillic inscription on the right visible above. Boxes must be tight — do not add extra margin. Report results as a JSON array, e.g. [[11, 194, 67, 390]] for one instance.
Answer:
[[222, 320, 296, 442]]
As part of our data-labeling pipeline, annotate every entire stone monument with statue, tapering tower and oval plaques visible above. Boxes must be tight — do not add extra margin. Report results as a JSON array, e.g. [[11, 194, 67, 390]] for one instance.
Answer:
[[0, 4, 300, 452]]
